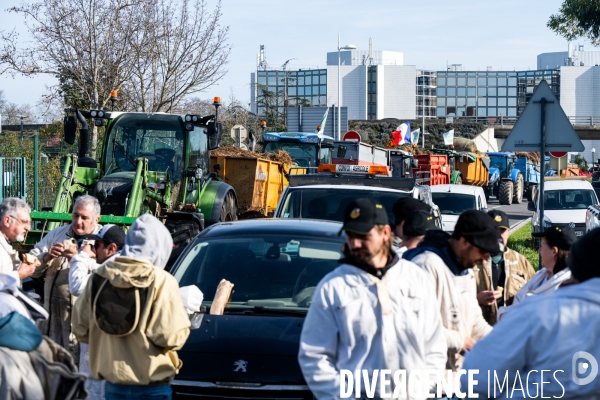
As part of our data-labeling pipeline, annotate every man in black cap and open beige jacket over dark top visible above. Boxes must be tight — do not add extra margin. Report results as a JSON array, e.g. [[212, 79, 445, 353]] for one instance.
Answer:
[[473, 210, 535, 325]]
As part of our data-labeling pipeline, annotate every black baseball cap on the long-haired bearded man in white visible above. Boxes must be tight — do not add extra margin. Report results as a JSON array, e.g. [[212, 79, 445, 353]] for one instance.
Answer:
[[338, 198, 389, 235]]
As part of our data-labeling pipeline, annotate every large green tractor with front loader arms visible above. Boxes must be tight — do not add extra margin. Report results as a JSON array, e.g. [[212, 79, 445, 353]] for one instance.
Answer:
[[27, 98, 237, 264]]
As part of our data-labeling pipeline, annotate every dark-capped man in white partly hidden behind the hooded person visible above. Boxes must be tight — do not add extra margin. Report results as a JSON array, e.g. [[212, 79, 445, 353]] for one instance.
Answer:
[[69, 225, 126, 400]]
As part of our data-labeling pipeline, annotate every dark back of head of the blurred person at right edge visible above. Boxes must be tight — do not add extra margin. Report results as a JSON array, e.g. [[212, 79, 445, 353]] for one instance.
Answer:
[[567, 228, 600, 282]]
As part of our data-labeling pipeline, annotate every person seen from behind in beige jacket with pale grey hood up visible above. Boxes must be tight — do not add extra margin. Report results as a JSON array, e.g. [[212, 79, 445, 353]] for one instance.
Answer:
[[72, 214, 190, 400]]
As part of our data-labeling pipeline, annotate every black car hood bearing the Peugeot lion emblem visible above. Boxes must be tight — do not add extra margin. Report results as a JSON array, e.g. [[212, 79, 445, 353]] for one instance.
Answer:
[[177, 314, 306, 385]]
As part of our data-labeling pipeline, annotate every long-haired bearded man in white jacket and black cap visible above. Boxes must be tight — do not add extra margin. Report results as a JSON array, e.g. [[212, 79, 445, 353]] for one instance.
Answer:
[[298, 199, 446, 400]]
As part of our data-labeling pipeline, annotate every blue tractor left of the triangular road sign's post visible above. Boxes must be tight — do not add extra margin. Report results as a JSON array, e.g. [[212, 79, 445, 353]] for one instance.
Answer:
[[485, 152, 540, 205]]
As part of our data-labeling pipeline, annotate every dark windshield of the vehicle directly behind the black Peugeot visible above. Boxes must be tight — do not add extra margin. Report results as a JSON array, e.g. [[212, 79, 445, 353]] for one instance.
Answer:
[[279, 188, 412, 225]]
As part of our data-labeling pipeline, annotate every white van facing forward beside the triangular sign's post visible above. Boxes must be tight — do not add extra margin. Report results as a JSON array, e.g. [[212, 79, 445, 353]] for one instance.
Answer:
[[527, 177, 598, 236]]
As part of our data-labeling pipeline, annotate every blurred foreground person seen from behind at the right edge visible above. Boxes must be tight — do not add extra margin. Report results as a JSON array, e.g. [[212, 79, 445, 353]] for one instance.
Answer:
[[463, 228, 600, 400]]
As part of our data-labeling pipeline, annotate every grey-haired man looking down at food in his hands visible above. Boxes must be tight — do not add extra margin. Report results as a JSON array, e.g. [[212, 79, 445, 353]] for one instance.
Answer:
[[29, 195, 102, 365]]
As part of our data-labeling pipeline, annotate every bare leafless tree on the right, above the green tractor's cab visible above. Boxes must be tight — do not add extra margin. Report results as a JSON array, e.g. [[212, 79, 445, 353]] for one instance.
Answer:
[[125, 0, 231, 112]]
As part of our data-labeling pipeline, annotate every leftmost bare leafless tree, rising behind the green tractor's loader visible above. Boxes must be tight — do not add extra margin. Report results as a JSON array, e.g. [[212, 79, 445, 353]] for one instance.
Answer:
[[0, 0, 153, 156]]
